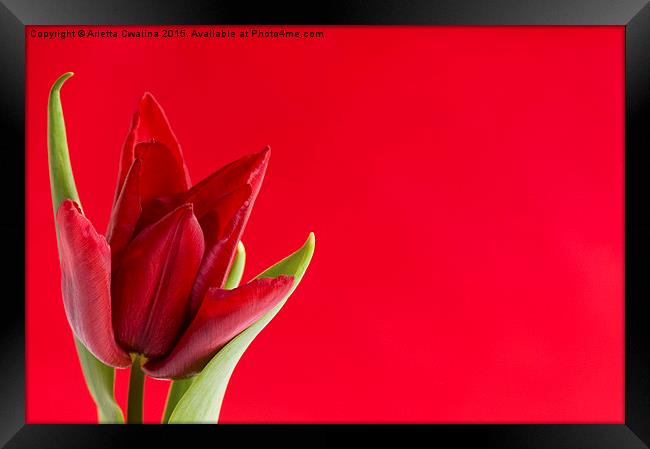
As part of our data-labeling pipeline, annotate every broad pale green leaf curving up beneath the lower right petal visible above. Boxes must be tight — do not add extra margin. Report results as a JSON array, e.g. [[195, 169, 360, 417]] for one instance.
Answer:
[[169, 233, 315, 423]]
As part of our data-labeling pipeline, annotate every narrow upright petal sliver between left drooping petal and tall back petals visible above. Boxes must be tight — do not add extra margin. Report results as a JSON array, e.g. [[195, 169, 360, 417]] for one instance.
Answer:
[[106, 159, 142, 270]]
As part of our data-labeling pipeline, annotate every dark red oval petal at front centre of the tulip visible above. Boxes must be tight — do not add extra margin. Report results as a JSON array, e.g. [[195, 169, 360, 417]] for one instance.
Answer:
[[113, 204, 204, 358]]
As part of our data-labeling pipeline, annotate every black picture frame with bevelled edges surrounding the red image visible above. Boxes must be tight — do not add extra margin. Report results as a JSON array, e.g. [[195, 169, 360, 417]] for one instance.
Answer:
[[0, 0, 650, 449]]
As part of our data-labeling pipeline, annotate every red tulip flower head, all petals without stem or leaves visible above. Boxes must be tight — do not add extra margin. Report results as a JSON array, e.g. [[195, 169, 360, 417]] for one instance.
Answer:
[[56, 93, 293, 378]]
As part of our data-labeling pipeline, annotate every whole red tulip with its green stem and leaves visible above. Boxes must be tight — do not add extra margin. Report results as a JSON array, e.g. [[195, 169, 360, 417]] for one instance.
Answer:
[[48, 73, 315, 423]]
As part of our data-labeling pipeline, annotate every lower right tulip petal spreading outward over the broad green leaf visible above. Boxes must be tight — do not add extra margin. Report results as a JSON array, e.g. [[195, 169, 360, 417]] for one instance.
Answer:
[[143, 276, 293, 379]]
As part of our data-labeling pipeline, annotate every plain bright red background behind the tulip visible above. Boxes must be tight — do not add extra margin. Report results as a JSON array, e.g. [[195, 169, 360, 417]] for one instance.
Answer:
[[26, 27, 624, 423]]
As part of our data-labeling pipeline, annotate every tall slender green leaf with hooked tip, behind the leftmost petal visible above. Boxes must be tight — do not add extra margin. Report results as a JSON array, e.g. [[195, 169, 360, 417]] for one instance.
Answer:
[[47, 72, 124, 423]]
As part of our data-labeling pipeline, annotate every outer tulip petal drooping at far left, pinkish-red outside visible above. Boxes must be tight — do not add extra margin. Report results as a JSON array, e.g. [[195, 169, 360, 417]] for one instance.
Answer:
[[56, 200, 131, 367]]
